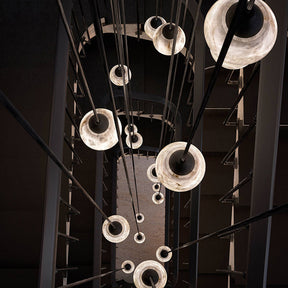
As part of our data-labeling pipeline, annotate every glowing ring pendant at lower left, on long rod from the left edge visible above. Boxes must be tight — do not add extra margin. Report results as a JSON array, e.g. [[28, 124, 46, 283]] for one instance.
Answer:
[[102, 215, 130, 243]]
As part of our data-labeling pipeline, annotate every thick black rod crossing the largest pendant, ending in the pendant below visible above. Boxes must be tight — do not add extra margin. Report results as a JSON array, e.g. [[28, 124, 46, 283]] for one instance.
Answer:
[[181, 0, 247, 162]]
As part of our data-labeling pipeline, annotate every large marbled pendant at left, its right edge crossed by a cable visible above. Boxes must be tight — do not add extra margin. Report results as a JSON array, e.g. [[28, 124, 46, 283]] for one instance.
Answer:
[[79, 108, 122, 151]]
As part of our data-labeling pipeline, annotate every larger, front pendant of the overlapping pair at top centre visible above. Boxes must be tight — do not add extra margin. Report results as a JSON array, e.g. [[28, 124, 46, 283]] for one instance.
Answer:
[[153, 23, 186, 56]]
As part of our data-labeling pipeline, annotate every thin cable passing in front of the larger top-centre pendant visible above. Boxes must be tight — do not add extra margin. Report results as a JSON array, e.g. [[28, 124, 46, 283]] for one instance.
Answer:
[[159, 0, 181, 151]]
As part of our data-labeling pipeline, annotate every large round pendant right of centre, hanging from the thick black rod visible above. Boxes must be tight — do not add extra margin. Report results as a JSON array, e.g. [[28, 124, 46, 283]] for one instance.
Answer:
[[156, 141, 206, 192]]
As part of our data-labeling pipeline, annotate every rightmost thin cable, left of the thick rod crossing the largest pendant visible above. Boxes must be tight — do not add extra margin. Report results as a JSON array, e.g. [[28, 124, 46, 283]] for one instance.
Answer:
[[170, 0, 203, 141]]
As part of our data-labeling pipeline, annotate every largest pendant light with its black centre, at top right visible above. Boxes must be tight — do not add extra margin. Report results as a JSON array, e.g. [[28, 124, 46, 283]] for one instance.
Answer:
[[204, 0, 277, 69]]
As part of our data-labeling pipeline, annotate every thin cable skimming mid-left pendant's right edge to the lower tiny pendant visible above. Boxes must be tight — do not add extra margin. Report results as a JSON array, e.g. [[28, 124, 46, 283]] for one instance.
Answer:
[[90, 0, 139, 234]]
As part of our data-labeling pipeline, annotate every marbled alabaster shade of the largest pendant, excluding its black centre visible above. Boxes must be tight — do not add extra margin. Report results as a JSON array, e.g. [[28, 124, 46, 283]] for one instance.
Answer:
[[204, 0, 277, 69]]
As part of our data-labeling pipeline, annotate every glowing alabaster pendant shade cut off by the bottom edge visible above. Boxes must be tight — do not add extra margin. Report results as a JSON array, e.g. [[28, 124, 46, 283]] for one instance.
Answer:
[[133, 260, 167, 288]]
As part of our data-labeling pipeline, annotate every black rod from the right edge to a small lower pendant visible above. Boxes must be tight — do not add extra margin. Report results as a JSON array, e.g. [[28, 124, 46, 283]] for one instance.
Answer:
[[172, 203, 288, 253]]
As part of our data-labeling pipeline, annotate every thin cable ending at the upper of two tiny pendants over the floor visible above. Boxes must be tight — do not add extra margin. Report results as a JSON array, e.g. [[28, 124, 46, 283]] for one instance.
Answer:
[[119, 0, 140, 213]]
